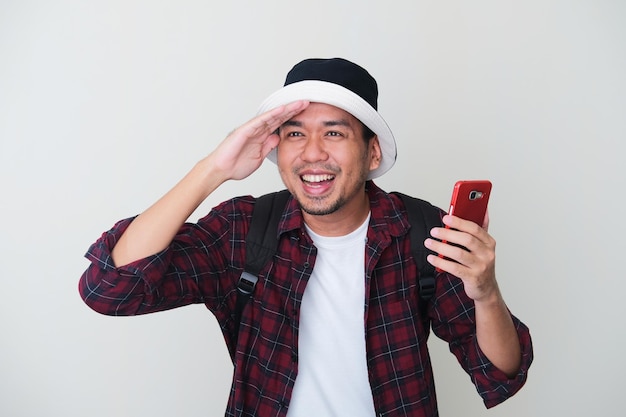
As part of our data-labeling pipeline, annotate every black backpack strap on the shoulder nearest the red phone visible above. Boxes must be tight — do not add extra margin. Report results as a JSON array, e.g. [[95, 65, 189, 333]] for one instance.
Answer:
[[394, 192, 442, 301]]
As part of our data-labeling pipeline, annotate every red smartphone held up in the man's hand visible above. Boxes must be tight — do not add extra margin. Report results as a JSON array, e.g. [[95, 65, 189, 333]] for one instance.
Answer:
[[436, 180, 491, 272]]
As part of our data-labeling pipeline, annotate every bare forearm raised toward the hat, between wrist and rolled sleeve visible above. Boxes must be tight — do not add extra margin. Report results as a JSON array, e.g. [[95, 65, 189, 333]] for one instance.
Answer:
[[111, 156, 224, 266]]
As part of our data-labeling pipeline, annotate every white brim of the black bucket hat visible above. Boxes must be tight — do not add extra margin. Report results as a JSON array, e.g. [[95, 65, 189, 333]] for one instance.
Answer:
[[257, 80, 397, 179]]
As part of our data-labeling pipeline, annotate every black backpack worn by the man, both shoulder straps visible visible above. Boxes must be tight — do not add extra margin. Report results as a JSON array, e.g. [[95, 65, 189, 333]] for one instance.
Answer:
[[234, 190, 441, 335]]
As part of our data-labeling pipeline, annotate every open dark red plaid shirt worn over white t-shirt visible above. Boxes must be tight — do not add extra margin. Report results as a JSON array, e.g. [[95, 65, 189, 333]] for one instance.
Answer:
[[79, 182, 532, 417]]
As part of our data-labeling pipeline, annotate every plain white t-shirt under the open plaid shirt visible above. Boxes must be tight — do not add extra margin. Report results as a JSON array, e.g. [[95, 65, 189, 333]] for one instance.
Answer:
[[287, 216, 375, 417]]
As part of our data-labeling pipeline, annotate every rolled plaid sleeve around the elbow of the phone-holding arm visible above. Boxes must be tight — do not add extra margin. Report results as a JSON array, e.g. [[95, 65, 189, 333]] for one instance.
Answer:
[[431, 274, 533, 408]]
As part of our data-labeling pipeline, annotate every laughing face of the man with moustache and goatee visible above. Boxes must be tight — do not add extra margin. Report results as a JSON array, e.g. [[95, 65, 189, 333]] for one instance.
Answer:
[[277, 103, 381, 215]]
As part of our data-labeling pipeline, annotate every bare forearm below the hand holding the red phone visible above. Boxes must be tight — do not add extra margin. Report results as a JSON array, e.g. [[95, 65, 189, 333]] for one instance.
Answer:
[[475, 291, 521, 377]]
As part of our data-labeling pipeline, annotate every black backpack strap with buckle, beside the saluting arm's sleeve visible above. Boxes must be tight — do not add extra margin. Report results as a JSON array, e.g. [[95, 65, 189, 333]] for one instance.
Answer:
[[235, 190, 289, 338]]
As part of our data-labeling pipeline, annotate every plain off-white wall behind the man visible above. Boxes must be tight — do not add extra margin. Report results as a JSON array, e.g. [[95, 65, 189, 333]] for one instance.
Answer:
[[0, 0, 626, 417]]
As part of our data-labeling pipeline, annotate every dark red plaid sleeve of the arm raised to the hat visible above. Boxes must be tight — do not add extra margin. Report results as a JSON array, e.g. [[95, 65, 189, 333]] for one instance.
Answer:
[[79, 198, 247, 316]]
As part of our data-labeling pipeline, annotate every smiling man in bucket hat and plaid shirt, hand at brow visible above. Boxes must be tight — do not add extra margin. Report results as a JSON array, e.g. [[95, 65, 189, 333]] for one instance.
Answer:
[[79, 58, 532, 417]]
